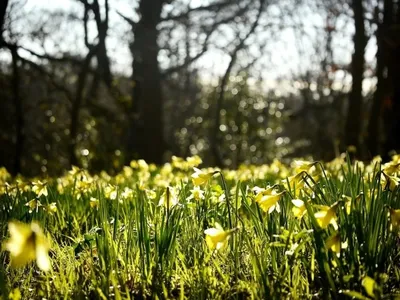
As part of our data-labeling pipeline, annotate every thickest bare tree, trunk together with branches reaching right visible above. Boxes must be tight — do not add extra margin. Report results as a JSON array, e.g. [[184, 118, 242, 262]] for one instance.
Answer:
[[121, 0, 255, 163]]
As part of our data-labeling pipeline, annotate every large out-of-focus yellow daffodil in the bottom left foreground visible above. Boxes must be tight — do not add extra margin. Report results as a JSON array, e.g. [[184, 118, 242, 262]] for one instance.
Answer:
[[4, 222, 51, 271]]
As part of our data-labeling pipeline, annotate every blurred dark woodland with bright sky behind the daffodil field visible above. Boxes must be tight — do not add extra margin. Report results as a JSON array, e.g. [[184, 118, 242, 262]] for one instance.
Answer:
[[0, 0, 400, 176]]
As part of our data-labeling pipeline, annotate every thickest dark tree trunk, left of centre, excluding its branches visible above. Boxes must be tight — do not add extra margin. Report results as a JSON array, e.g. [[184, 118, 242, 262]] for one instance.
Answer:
[[127, 0, 165, 164]]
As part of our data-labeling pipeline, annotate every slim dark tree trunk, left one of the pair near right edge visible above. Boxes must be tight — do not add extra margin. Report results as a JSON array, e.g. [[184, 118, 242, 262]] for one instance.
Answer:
[[345, 0, 366, 155]]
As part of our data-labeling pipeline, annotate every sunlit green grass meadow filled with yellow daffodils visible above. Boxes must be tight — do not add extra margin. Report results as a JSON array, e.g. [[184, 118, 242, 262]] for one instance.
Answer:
[[0, 156, 400, 299]]
